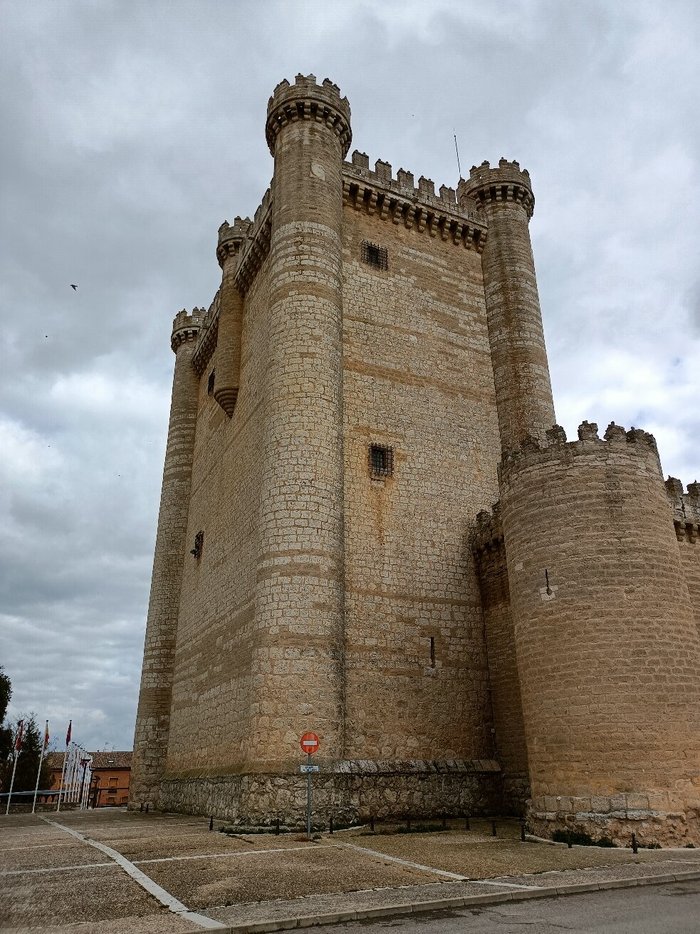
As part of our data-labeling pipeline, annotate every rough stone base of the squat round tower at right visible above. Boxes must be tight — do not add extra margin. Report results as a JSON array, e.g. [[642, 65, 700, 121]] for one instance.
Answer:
[[527, 794, 700, 847]]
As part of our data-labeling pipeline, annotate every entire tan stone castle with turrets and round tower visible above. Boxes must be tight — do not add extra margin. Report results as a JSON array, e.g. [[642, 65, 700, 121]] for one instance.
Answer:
[[130, 75, 700, 844]]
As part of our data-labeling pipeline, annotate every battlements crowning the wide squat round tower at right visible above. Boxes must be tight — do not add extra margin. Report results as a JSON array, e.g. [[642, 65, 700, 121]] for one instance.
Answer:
[[499, 421, 661, 482]]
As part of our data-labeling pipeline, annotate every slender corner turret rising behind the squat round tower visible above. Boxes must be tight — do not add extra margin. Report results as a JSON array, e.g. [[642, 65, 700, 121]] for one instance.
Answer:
[[458, 159, 554, 455]]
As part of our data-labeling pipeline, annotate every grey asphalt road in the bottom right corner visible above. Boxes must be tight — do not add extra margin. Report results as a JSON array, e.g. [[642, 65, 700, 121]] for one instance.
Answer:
[[313, 880, 700, 934]]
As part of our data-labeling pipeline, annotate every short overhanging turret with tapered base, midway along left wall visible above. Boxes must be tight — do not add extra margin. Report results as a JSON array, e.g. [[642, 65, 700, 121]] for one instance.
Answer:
[[214, 217, 251, 418]]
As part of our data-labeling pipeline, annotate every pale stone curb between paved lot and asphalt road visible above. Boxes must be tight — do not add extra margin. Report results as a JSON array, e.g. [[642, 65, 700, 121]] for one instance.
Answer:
[[211, 869, 700, 934]]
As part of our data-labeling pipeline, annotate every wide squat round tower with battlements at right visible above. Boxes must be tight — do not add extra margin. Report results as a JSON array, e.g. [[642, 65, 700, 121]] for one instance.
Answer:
[[500, 422, 700, 845]]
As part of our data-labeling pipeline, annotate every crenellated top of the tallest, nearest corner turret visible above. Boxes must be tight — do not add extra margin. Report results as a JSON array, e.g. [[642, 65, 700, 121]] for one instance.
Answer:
[[265, 75, 352, 156]]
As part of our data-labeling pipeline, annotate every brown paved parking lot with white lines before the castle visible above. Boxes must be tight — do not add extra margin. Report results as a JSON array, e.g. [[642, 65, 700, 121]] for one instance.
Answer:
[[0, 810, 700, 934]]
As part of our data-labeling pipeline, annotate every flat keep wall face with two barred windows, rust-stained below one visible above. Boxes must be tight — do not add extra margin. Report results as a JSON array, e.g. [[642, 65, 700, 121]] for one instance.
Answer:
[[343, 176, 499, 759]]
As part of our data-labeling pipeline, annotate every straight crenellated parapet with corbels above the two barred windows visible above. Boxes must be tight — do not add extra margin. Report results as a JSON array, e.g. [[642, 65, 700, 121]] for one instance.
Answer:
[[343, 150, 486, 253]]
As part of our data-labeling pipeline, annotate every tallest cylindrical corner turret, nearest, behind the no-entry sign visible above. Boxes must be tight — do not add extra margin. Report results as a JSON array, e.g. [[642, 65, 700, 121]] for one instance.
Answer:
[[250, 75, 351, 768]]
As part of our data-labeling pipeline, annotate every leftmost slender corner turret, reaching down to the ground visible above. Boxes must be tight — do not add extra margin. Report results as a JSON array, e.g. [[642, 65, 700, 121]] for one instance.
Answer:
[[129, 309, 204, 808]]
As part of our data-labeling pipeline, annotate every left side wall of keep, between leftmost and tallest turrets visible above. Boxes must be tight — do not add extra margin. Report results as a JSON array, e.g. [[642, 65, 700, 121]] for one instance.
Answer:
[[167, 265, 269, 776]]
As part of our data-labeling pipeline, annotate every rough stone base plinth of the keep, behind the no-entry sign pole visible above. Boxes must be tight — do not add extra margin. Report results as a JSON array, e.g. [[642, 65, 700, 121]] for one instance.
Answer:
[[142, 759, 503, 826]]
